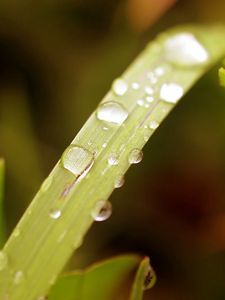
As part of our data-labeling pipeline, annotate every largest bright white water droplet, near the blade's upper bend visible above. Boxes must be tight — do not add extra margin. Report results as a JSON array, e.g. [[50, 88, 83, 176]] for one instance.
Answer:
[[165, 32, 209, 67]]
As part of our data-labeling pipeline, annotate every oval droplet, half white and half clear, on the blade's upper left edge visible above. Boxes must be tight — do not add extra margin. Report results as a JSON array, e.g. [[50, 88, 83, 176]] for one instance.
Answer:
[[96, 101, 128, 125]]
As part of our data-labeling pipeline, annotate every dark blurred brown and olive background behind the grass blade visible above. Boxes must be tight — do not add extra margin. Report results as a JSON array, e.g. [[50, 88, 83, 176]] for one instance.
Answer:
[[0, 0, 225, 300]]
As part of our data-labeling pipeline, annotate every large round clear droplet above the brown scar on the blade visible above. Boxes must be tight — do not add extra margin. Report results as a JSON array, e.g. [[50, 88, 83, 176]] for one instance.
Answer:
[[62, 145, 94, 176]]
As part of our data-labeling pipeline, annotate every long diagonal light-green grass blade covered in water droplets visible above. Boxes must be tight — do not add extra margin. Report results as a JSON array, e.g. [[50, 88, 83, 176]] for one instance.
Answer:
[[0, 26, 225, 300]]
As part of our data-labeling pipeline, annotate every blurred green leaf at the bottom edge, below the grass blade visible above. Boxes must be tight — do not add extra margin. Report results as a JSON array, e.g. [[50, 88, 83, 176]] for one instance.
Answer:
[[49, 255, 149, 300]]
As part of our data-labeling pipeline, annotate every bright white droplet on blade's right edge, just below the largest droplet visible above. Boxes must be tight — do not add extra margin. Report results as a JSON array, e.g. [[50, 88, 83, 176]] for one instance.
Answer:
[[160, 83, 184, 103]]
